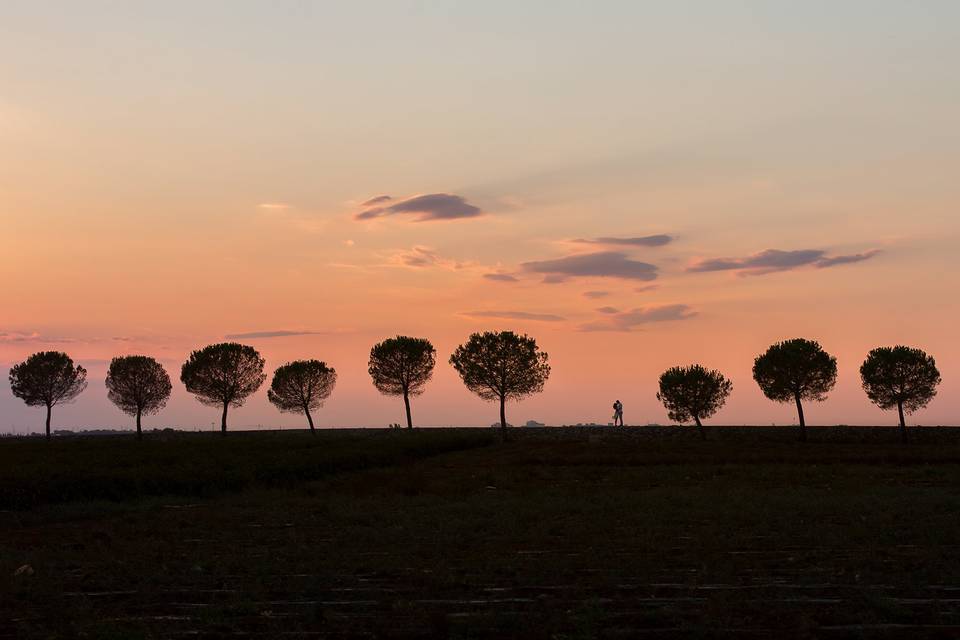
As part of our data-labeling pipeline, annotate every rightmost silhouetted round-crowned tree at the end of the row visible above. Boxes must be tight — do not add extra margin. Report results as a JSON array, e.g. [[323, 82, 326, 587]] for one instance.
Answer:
[[860, 346, 940, 442]]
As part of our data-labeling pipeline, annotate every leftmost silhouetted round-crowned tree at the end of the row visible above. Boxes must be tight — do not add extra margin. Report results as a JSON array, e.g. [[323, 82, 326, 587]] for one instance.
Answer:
[[10, 351, 87, 440]]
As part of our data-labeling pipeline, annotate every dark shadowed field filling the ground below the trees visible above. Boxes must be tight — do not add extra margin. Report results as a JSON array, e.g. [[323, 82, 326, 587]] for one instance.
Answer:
[[0, 427, 960, 639]]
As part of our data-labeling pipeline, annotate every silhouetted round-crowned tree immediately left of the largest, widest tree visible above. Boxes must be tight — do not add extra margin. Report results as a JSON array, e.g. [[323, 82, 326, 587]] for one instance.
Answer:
[[367, 336, 437, 429]]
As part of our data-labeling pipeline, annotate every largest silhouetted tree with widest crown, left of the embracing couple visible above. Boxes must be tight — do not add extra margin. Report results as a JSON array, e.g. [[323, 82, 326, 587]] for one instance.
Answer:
[[450, 331, 550, 439]]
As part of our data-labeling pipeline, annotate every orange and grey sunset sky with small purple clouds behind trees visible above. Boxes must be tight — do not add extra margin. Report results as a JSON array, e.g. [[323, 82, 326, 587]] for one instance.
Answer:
[[0, 0, 960, 433]]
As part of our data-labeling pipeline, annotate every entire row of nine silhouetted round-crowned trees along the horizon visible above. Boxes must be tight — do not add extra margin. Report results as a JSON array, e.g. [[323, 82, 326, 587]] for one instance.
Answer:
[[3, 331, 941, 442]]
